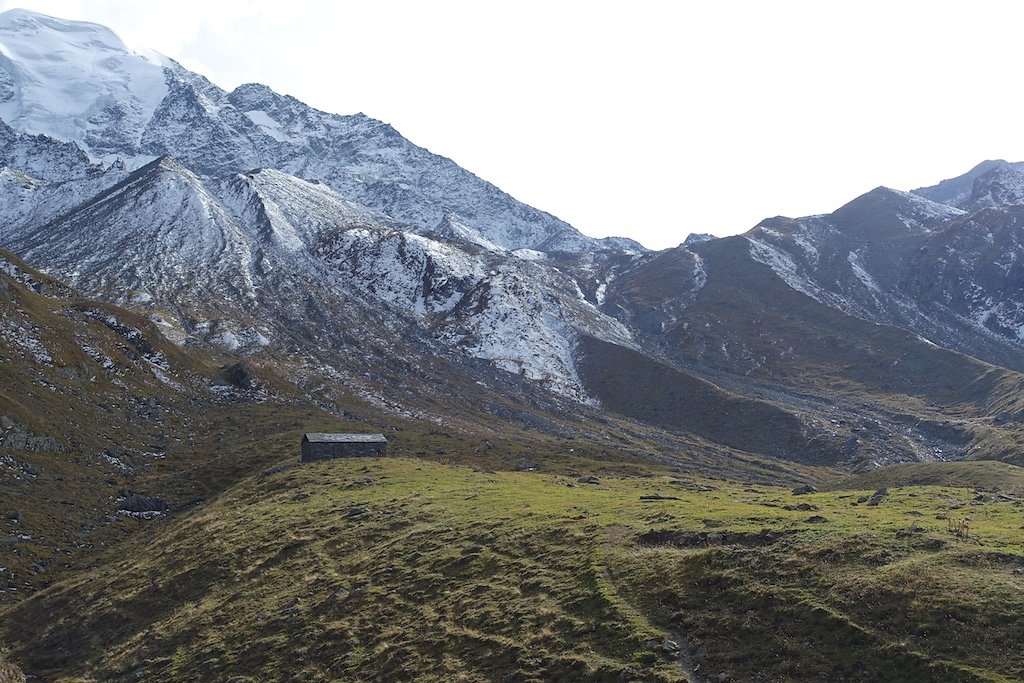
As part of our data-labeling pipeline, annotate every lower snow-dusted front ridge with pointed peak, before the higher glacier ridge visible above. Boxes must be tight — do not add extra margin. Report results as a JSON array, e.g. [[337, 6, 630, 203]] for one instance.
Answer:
[[6, 147, 631, 400]]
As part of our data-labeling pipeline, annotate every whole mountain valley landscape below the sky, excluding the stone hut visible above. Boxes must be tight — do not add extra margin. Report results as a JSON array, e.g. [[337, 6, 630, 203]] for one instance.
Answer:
[[0, 10, 1024, 682]]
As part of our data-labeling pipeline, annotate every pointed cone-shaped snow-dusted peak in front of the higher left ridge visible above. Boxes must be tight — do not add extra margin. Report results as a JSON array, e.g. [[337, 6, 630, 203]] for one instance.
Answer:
[[13, 153, 255, 301]]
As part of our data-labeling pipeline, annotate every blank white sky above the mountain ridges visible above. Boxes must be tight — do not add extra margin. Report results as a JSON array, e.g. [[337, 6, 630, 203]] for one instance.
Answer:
[[0, 0, 1024, 248]]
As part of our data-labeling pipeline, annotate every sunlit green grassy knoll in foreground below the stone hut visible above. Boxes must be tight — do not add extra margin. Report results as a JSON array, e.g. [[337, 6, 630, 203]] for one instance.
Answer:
[[0, 458, 1024, 681]]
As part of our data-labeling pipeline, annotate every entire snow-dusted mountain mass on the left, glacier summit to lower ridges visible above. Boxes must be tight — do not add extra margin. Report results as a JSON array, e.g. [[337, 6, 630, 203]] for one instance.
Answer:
[[0, 10, 642, 400]]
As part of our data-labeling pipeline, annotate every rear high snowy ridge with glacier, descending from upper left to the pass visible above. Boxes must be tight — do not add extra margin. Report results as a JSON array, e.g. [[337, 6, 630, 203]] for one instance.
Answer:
[[0, 10, 642, 258]]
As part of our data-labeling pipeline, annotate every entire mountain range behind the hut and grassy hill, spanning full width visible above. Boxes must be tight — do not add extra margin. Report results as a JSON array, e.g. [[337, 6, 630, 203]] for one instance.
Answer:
[[0, 10, 1024, 468]]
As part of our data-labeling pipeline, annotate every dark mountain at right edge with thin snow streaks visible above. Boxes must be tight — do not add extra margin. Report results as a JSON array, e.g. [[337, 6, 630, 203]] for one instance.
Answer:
[[716, 181, 1024, 369]]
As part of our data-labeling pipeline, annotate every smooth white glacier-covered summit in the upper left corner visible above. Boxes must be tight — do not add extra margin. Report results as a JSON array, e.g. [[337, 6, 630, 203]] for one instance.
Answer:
[[0, 9, 170, 158]]
